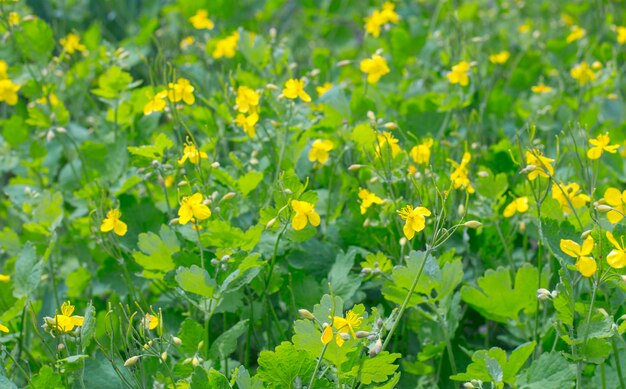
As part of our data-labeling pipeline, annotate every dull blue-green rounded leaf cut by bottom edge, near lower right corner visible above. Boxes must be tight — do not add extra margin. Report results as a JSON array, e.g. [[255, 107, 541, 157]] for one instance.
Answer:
[[517, 352, 576, 389]]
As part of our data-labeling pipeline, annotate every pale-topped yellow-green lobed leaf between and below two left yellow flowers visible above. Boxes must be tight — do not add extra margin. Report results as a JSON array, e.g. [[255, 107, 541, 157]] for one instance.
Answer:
[[133, 225, 180, 279]]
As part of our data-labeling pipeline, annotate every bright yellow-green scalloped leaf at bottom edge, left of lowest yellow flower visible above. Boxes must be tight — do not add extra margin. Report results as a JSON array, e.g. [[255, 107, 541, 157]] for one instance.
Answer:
[[257, 342, 315, 388]]
